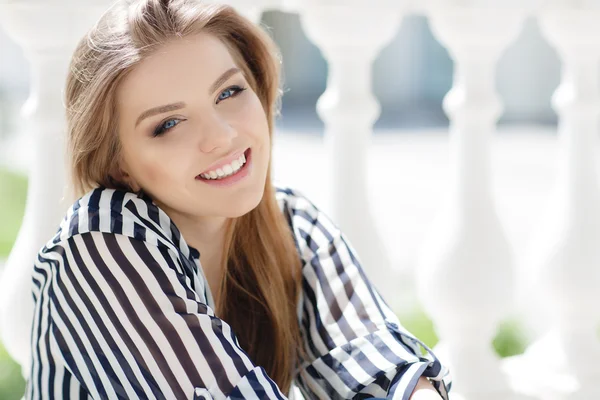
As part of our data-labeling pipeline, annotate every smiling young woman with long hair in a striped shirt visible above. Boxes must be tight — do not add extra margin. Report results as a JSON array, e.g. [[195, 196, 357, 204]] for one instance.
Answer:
[[26, 0, 449, 400]]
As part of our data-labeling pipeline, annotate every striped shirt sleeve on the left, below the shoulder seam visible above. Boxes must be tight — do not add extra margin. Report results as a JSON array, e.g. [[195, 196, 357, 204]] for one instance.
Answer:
[[50, 232, 286, 400]]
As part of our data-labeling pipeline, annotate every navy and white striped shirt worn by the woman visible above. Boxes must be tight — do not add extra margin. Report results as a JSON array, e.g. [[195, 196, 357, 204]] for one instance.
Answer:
[[24, 188, 450, 400]]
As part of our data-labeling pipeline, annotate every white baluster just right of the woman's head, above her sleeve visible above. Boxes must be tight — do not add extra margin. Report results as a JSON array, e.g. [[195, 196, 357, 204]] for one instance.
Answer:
[[294, 0, 401, 291]]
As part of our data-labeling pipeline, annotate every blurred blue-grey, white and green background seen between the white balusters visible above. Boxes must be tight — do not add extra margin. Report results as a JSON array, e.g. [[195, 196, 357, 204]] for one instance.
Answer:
[[0, 5, 592, 400]]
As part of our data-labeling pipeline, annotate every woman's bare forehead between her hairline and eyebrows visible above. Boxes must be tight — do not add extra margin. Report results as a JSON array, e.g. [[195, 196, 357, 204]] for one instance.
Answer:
[[117, 33, 236, 108]]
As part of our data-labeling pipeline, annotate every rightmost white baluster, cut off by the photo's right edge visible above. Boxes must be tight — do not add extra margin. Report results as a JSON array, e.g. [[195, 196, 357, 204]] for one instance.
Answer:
[[513, 1, 600, 400]]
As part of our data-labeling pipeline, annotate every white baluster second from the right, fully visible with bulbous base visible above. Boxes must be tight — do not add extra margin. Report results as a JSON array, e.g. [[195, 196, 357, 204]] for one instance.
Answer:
[[417, 0, 526, 400]]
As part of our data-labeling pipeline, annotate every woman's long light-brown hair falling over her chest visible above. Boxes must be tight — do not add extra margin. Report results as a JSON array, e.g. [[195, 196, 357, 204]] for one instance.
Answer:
[[65, 0, 303, 393]]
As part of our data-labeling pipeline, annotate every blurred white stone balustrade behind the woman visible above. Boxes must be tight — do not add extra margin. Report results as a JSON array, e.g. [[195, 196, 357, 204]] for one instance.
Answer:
[[0, 0, 600, 400]]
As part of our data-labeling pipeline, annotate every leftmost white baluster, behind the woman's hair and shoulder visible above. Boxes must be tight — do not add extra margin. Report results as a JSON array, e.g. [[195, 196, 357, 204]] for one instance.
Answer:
[[0, 0, 109, 374]]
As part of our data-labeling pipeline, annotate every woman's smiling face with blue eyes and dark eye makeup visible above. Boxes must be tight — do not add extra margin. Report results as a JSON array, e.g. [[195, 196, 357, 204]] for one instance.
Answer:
[[117, 33, 270, 217]]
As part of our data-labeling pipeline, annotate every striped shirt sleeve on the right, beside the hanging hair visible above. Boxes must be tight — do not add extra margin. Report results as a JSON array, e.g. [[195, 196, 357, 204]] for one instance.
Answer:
[[292, 198, 450, 400]]
